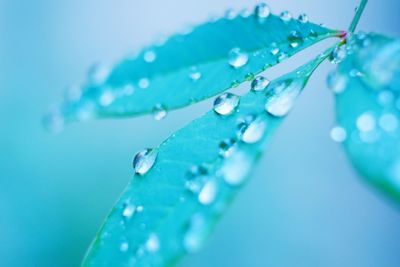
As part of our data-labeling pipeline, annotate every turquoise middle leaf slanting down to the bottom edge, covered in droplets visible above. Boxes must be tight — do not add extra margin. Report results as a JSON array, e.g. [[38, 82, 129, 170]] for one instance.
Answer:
[[83, 52, 324, 266]]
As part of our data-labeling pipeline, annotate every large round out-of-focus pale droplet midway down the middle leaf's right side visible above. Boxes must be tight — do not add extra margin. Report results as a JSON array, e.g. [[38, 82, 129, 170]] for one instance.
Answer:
[[220, 152, 252, 186]]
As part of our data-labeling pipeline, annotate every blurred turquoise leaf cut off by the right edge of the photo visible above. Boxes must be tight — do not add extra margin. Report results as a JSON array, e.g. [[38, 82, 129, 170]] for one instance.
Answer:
[[328, 33, 400, 201]]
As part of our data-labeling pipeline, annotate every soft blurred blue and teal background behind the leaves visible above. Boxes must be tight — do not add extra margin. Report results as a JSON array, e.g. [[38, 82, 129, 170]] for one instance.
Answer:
[[0, 0, 400, 267]]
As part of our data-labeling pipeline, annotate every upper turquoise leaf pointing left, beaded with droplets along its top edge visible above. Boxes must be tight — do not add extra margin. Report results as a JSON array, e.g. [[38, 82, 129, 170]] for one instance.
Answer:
[[48, 5, 339, 129]]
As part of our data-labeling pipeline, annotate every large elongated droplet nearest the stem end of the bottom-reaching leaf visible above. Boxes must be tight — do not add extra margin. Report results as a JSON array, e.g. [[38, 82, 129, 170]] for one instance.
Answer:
[[265, 79, 304, 117]]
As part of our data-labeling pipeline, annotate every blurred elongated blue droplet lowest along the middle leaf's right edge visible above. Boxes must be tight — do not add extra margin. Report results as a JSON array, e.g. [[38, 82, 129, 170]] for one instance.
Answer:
[[183, 214, 206, 253]]
